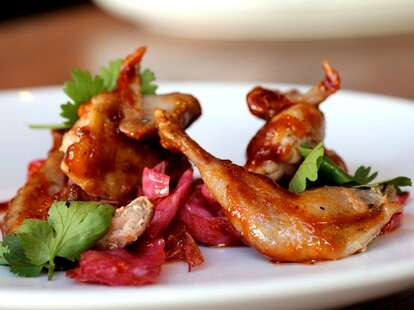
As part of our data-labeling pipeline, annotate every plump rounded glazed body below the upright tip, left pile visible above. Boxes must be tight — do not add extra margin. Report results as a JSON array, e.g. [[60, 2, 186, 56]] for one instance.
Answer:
[[60, 93, 175, 201]]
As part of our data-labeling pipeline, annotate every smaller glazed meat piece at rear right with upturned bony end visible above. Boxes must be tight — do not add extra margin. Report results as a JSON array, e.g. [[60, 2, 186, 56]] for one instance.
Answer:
[[245, 62, 346, 181]]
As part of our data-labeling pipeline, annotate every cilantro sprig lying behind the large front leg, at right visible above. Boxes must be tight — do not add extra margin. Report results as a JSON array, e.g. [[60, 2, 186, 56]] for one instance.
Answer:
[[289, 143, 412, 193]]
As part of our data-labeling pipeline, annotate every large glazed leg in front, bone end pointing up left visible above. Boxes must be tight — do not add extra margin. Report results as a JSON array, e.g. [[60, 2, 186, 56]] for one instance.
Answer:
[[156, 111, 401, 262]]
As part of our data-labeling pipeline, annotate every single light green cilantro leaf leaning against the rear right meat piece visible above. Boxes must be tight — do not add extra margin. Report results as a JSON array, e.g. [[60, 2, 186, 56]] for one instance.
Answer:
[[289, 143, 325, 193]]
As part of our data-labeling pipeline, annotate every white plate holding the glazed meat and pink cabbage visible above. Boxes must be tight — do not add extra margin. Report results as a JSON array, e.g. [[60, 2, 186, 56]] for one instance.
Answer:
[[0, 82, 414, 310]]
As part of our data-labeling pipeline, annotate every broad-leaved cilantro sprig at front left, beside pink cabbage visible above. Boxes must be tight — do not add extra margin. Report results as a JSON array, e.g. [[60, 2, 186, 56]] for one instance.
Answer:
[[0, 201, 114, 279]]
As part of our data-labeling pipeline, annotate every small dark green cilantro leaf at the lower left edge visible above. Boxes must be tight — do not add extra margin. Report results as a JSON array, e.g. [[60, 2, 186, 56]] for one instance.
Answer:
[[2, 234, 44, 277]]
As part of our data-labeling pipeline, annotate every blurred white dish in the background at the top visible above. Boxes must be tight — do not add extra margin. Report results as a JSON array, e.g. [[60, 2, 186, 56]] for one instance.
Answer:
[[94, 0, 414, 40]]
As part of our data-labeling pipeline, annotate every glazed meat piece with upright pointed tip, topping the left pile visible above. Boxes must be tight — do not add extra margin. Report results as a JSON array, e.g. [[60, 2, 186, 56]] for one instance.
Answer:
[[60, 48, 201, 202]]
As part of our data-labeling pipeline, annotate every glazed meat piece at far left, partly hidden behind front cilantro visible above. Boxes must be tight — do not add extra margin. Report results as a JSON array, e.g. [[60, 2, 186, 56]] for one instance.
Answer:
[[1, 131, 67, 234]]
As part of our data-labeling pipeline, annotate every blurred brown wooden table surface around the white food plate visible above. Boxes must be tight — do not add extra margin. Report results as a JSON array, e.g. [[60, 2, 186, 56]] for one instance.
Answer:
[[0, 5, 414, 309]]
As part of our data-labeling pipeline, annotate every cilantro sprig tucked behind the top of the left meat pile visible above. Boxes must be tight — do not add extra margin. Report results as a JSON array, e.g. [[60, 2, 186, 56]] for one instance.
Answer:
[[29, 59, 158, 129]]
